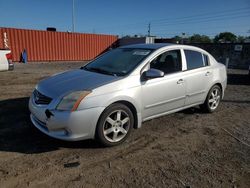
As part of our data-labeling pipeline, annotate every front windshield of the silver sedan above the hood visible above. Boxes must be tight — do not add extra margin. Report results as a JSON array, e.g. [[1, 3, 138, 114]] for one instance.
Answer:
[[83, 48, 152, 76]]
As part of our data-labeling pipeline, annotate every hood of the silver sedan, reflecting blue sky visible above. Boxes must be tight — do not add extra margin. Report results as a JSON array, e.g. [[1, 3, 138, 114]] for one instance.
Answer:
[[37, 69, 121, 98]]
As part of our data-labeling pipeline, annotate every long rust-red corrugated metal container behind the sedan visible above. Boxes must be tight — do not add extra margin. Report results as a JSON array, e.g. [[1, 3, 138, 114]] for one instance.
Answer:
[[0, 28, 118, 61]]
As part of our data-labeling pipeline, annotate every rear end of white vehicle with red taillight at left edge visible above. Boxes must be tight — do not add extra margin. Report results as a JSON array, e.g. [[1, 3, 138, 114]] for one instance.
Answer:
[[0, 50, 14, 71]]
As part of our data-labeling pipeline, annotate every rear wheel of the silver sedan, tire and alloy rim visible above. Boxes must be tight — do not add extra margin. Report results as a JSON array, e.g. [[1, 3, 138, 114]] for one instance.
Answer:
[[200, 85, 222, 113]]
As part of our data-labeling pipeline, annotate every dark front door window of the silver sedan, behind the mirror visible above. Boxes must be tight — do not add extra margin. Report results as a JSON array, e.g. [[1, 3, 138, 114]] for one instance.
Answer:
[[150, 50, 182, 74]]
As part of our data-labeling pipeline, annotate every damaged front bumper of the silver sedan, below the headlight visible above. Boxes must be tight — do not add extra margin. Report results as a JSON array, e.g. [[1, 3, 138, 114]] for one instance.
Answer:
[[29, 97, 104, 141]]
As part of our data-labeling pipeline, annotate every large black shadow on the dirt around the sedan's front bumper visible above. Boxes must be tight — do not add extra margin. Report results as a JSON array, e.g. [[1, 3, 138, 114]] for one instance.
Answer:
[[0, 97, 101, 154]]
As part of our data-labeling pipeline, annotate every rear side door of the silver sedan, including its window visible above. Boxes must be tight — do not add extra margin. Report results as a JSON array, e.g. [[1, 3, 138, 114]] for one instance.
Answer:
[[184, 49, 213, 106]]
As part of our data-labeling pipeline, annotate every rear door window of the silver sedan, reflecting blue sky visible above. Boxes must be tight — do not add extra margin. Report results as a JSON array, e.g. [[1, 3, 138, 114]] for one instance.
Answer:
[[184, 50, 204, 70]]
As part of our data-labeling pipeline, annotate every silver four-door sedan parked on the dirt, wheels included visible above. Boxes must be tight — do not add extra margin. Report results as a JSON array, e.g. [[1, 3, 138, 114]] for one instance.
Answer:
[[29, 44, 227, 146]]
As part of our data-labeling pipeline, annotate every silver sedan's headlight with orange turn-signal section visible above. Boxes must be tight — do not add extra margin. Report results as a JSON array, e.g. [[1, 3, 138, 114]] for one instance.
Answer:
[[56, 91, 91, 111]]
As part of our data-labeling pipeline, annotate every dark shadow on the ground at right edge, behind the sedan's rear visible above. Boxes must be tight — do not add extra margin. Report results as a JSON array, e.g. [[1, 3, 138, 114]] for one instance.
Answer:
[[227, 73, 250, 85]]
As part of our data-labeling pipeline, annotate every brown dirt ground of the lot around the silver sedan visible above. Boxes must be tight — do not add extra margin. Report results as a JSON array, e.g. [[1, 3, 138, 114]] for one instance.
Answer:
[[0, 63, 250, 188]]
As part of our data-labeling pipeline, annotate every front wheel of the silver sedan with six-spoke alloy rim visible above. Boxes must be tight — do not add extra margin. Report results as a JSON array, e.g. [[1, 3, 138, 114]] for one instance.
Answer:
[[96, 103, 134, 147]]
